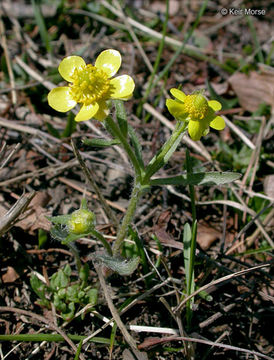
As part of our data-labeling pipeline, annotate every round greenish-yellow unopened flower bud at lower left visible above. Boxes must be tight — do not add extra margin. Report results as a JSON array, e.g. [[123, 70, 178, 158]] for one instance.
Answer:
[[67, 209, 95, 234]]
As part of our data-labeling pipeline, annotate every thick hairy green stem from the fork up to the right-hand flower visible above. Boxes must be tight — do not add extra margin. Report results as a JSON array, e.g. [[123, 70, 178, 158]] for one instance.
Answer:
[[143, 121, 186, 184]]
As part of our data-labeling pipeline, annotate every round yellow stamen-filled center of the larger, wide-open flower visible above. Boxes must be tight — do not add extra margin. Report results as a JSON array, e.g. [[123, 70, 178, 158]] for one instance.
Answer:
[[69, 64, 111, 105]]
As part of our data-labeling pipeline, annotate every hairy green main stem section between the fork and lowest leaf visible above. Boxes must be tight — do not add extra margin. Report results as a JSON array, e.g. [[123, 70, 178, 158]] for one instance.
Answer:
[[112, 183, 143, 256]]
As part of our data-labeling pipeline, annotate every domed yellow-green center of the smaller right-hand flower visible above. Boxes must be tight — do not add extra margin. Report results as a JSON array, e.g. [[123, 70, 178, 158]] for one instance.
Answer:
[[184, 94, 208, 121]]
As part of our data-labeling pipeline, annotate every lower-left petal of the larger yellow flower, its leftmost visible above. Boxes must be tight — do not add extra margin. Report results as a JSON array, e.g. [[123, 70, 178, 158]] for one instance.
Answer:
[[48, 86, 77, 112]]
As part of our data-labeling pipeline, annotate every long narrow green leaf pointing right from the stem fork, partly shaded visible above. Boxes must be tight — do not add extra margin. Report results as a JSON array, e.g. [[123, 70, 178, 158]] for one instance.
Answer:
[[150, 171, 242, 186]]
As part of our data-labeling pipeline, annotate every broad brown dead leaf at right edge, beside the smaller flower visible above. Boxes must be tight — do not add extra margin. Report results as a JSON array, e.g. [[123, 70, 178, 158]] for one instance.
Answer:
[[228, 69, 274, 112]]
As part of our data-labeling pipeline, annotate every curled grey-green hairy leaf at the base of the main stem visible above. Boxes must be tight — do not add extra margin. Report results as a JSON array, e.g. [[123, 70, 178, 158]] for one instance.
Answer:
[[95, 254, 139, 276]]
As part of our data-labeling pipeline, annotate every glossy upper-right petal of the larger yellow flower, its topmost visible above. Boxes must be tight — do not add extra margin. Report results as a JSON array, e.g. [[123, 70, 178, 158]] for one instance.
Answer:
[[95, 49, 122, 78]]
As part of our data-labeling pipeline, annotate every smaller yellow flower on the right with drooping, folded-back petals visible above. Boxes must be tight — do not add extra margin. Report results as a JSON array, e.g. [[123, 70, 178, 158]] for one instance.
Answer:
[[166, 88, 225, 141]]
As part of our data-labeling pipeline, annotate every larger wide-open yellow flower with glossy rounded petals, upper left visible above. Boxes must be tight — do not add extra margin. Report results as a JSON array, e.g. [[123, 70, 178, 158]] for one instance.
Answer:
[[48, 49, 135, 121]]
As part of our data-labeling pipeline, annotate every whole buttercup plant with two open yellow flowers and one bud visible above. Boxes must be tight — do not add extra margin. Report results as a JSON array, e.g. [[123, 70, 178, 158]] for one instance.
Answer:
[[48, 49, 240, 318]]
